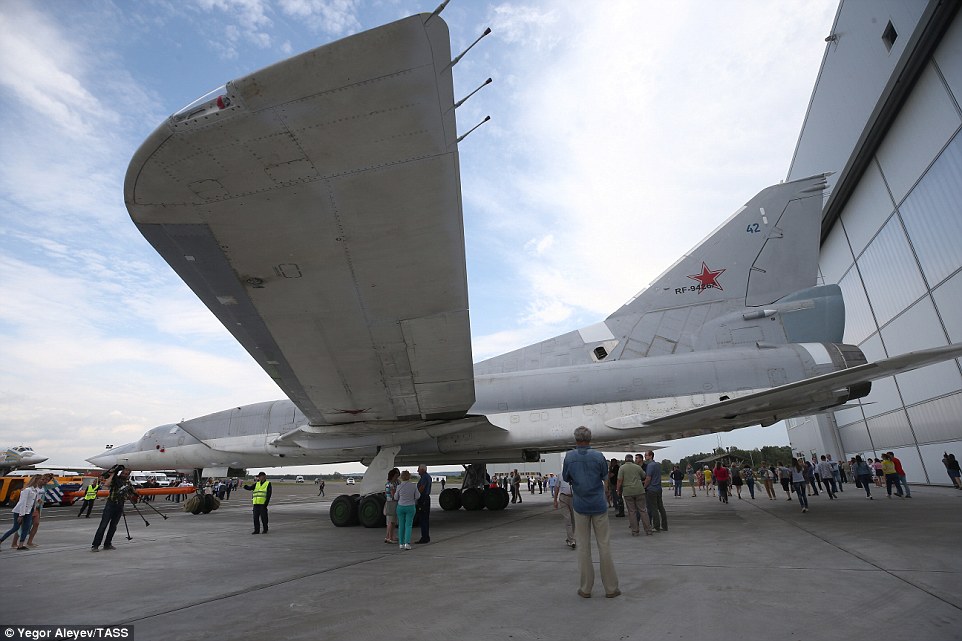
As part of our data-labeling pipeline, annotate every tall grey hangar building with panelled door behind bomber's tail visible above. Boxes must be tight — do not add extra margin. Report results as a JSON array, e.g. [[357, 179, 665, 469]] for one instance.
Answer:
[[788, 0, 962, 485]]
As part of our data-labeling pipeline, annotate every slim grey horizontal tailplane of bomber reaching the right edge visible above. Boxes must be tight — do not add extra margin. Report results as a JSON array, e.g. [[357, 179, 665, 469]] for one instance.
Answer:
[[605, 343, 962, 432]]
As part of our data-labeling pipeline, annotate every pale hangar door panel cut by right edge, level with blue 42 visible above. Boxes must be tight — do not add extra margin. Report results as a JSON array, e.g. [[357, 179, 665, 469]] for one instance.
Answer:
[[899, 135, 962, 287]]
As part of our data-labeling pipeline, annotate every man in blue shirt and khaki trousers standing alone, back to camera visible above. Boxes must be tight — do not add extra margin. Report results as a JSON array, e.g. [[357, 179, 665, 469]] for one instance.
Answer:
[[561, 425, 621, 599]]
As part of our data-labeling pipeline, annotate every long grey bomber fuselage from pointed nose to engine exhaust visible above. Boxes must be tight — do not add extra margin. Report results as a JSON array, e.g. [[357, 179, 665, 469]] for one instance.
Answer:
[[90, 343, 857, 469]]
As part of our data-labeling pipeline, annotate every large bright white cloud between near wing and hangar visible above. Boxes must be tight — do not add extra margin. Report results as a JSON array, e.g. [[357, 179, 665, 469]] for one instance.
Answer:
[[459, 2, 834, 350]]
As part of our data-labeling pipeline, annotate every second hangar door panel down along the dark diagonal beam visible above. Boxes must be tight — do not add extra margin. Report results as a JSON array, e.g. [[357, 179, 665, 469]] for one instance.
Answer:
[[876, 64, 962, 202]]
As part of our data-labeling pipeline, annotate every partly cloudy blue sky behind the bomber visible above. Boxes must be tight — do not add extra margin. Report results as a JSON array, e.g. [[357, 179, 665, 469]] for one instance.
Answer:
[[0, 0, 837, 469]]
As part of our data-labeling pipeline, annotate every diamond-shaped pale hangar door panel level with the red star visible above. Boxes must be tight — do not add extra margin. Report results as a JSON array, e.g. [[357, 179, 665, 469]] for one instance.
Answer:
[[857, 218, 926, 325]]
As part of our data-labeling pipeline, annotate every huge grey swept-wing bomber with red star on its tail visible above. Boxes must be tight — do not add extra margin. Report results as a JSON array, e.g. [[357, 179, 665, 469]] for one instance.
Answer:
[[89, 7, 962, 526]]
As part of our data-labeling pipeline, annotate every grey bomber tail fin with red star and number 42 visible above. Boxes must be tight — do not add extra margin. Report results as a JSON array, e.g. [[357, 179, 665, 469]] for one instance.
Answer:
[[605, 174, 828, 359]]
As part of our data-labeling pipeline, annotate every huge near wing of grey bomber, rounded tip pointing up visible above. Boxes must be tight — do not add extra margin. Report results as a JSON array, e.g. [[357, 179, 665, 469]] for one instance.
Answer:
[[124, 14, 474, 424]]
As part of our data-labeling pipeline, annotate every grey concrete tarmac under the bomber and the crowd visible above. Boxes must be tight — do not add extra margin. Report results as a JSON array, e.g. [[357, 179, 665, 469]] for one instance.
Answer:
[[0, 484, 962, 641]]
